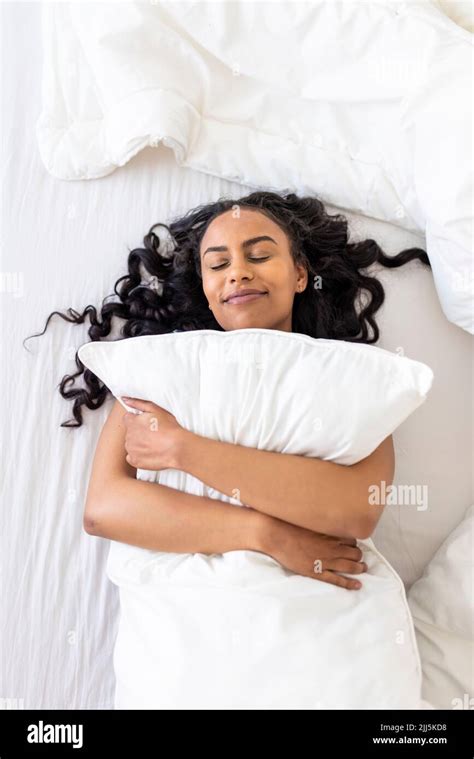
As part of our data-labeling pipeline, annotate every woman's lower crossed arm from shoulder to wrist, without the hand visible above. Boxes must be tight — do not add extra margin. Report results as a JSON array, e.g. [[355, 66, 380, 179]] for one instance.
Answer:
[[83, 400, 266, 553]]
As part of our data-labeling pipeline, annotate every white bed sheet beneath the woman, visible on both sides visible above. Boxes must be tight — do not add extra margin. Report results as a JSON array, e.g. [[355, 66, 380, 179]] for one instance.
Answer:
[[0, 3, 473, 709]]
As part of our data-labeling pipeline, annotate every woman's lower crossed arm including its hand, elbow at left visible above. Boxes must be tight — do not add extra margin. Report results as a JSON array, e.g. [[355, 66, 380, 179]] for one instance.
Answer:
[[83, 401, 367, 589]]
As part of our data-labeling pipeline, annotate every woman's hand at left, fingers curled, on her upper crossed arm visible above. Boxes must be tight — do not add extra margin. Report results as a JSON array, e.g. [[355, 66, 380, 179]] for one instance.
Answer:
[[122, 396, 186, 471]]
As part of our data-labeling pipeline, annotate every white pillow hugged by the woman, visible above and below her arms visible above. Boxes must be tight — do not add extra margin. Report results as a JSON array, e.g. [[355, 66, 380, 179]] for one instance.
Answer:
[[79, 328, 433, 709]]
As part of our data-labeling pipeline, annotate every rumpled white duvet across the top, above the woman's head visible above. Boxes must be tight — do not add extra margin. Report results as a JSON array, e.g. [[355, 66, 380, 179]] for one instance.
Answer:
[[37, 0, 474, 333]]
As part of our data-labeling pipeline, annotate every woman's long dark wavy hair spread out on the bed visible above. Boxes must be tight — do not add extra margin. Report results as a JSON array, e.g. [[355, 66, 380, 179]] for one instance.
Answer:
[[22, 191, 430, 427]]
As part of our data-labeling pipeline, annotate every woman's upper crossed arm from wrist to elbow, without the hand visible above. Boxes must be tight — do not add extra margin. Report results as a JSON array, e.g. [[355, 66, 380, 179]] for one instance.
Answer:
[[175, 430, 395, 539]]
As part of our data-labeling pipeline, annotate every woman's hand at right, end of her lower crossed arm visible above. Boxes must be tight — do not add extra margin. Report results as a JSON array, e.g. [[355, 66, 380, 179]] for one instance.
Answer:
[[260, 515, 367, 590]]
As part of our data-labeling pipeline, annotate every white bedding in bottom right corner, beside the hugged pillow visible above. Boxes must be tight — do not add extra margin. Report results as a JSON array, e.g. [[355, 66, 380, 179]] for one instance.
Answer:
[[408, 506, 474, 709]]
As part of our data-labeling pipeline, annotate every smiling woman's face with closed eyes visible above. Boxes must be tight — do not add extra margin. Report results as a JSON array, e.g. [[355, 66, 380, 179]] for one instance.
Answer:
[[200, 204, 308, 332]]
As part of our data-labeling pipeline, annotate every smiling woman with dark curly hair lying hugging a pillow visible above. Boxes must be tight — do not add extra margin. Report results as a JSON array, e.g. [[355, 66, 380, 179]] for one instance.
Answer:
[[23, 192, 429, 590]]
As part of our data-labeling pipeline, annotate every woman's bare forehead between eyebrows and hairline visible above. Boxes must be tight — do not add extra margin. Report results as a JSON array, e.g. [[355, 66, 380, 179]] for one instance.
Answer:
[[201, 208, 286, 250]]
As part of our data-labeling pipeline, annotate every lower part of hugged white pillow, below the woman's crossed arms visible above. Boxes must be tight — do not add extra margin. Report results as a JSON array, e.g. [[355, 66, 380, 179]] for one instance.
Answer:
[[107, 516, 426, 709]]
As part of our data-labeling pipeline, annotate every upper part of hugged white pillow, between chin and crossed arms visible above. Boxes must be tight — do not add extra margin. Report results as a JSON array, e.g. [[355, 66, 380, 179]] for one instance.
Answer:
[[78, 328, 433, 464]]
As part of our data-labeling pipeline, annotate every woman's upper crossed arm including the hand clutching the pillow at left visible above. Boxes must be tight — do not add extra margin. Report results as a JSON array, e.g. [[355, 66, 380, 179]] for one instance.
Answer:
[[115, 398, 395, 538]]
